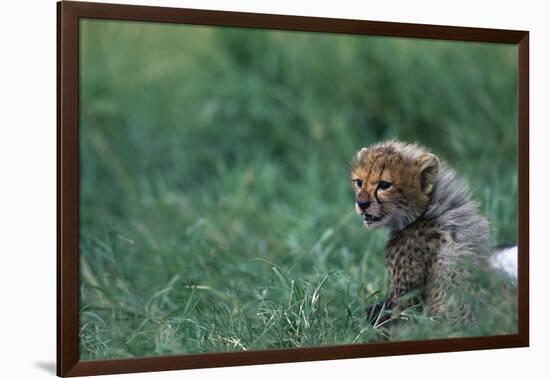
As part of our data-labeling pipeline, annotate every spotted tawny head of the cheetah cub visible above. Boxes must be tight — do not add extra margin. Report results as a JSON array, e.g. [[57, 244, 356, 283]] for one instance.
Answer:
[[351, 141, 439, 229]]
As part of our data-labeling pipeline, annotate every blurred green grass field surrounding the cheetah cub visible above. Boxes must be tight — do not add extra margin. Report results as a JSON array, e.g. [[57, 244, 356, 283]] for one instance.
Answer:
[[80, 20, 517, 359]]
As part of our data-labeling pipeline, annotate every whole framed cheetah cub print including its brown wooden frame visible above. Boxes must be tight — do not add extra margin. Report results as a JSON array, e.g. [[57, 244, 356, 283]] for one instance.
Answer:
[[57, 1, 529, 376]]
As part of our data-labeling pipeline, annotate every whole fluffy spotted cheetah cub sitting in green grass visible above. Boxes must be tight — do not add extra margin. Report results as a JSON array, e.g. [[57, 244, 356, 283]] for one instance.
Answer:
[[351, 141, 489, 320]]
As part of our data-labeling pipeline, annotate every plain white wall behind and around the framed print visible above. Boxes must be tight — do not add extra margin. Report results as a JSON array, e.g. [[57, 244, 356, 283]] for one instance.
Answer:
[[0, 0, 550, 378]]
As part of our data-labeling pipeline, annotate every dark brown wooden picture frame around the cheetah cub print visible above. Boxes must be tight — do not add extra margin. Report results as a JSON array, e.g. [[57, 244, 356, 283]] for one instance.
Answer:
[[57, 1, 529, 376]]
